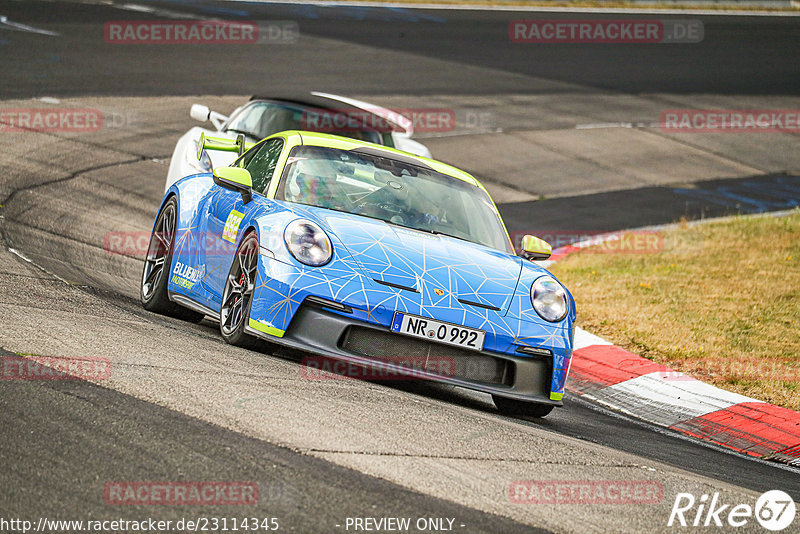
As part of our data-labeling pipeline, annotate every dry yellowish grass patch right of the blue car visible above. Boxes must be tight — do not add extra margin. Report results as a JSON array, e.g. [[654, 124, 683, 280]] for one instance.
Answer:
[[551, 212, 800, 411]]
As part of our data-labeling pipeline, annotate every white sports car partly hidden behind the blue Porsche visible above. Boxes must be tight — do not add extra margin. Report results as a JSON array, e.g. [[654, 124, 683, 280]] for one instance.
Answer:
[[164, 92, 431, 191]]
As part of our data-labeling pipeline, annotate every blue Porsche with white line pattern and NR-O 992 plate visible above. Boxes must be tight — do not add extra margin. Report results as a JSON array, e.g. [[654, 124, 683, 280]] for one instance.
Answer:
[[141, 131, 575, 417]]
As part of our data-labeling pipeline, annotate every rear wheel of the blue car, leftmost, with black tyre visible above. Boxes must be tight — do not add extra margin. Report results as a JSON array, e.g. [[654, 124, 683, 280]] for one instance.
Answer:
[[139, 197, 203, 322]]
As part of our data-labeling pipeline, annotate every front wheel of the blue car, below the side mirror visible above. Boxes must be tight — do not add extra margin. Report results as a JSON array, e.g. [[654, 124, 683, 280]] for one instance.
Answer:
[[219, 233, 258, 348]]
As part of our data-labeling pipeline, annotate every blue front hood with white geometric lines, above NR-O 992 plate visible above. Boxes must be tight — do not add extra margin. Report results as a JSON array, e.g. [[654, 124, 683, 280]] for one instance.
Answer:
[[296, 208, 522, 314]]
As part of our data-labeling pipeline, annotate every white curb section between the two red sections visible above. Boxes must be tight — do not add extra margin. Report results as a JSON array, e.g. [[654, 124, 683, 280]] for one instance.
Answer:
[[587, 372, 763, 426]]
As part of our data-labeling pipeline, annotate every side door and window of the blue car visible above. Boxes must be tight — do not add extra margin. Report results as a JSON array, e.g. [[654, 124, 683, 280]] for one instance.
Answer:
[[204, 137, 284, 308]]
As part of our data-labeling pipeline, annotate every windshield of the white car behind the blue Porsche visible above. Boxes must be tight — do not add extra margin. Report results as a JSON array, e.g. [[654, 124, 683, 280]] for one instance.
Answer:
[[226, 102, 386, 144]]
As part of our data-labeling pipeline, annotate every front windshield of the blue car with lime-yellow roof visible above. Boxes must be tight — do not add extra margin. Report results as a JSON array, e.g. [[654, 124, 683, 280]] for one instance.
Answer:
[[277, 146, 512, 253]]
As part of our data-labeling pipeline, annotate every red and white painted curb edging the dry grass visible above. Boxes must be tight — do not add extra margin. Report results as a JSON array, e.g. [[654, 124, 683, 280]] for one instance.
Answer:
[[553, 212, 800, 465]]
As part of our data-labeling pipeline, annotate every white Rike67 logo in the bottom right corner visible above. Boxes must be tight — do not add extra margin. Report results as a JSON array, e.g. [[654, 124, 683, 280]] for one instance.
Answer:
[[667, 490, 797, 532]]
